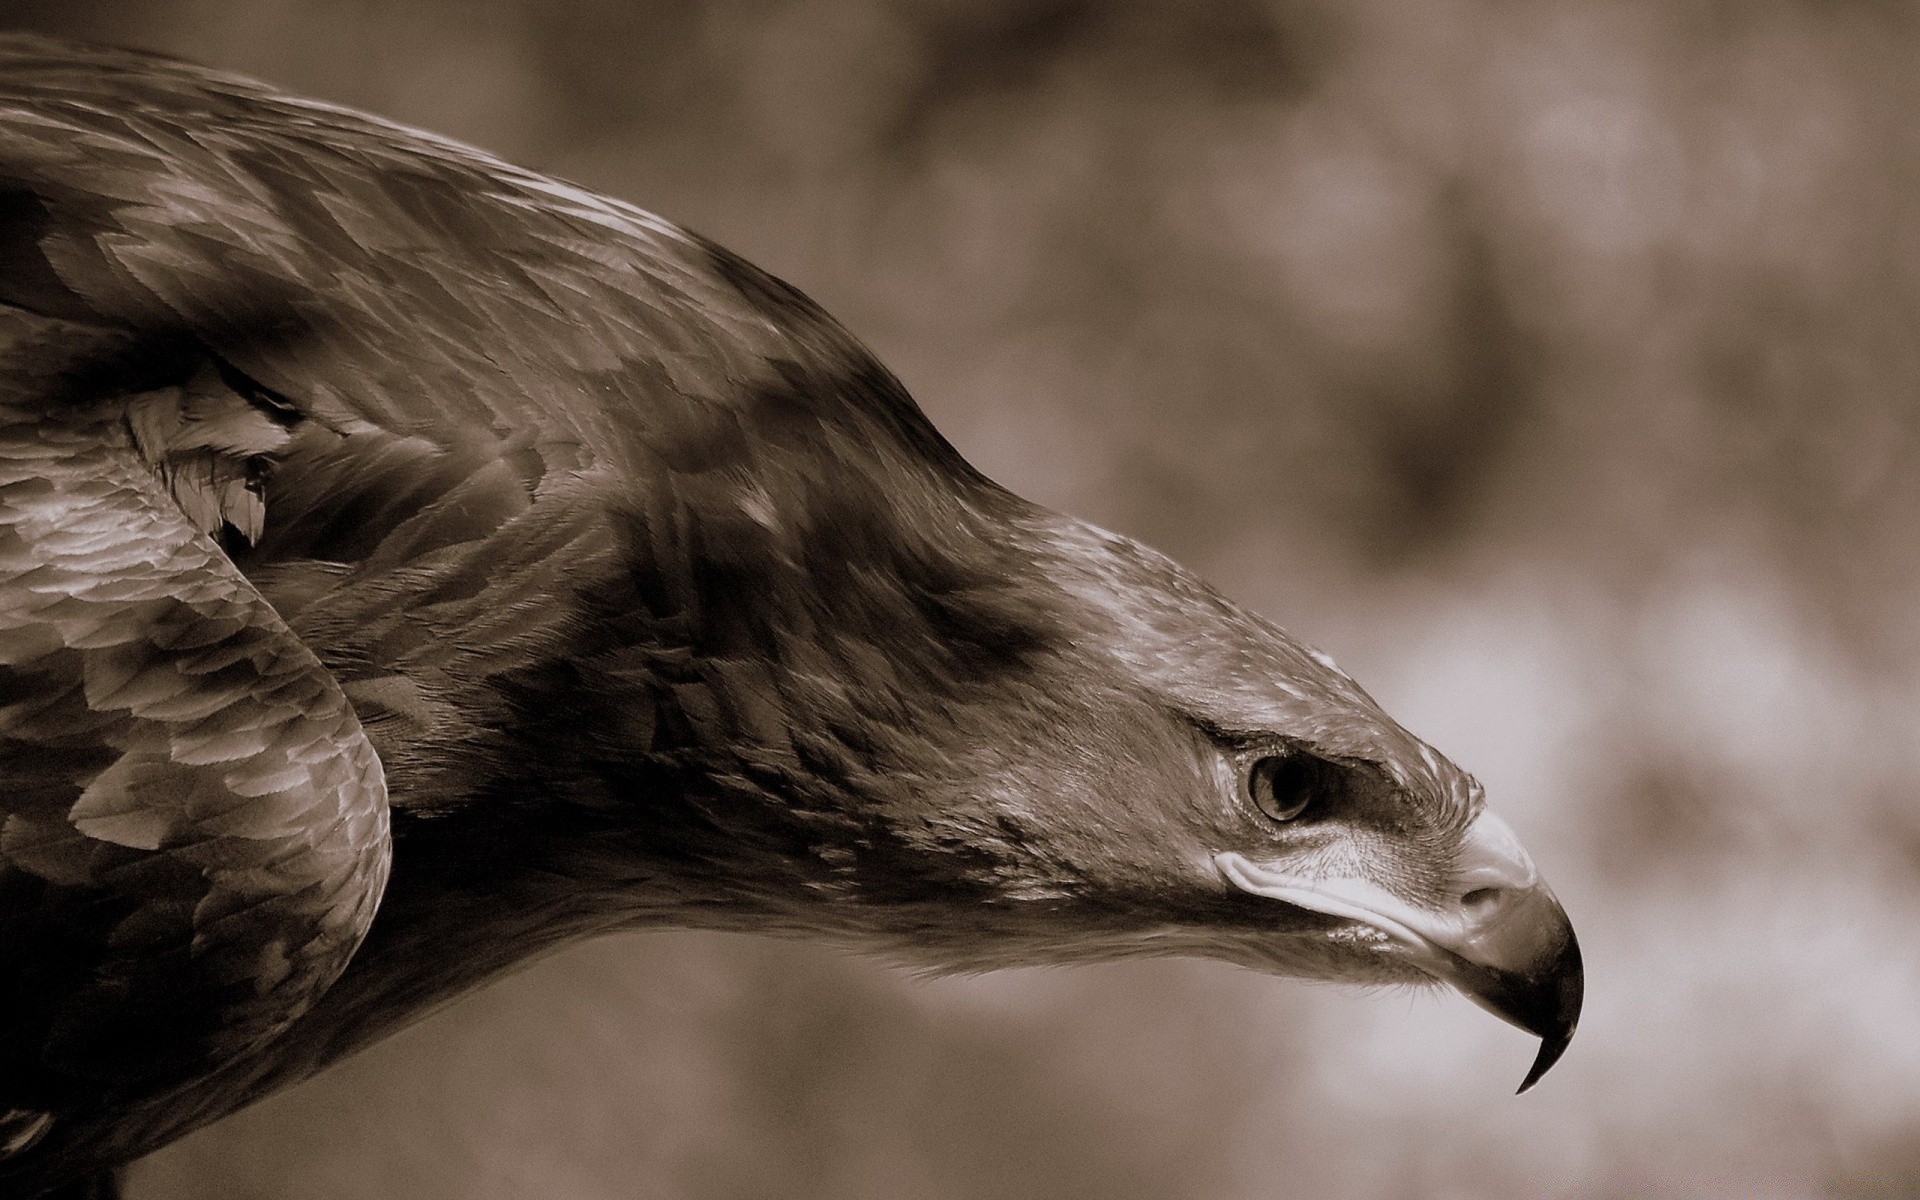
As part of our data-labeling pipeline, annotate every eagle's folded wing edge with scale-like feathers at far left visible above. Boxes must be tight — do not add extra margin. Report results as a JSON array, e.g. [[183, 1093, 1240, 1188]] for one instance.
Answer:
[[0, 297, 388, 1128]]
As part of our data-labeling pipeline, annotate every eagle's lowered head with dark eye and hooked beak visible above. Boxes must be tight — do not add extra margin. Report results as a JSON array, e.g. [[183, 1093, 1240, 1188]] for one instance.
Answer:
[[1014, 518, 1582, 1091]]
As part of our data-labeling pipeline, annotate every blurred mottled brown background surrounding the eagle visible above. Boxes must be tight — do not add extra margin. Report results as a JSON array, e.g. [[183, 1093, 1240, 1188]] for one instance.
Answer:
[[0, 0, 1920, 1200]]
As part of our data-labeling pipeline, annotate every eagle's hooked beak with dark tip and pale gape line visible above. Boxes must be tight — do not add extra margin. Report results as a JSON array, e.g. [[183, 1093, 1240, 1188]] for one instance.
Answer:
[[1213, 810, 1584, 1092]]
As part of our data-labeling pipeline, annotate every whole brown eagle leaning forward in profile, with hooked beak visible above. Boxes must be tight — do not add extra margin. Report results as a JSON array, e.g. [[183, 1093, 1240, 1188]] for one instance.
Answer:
[[0, 35, 1582, 1196]]
